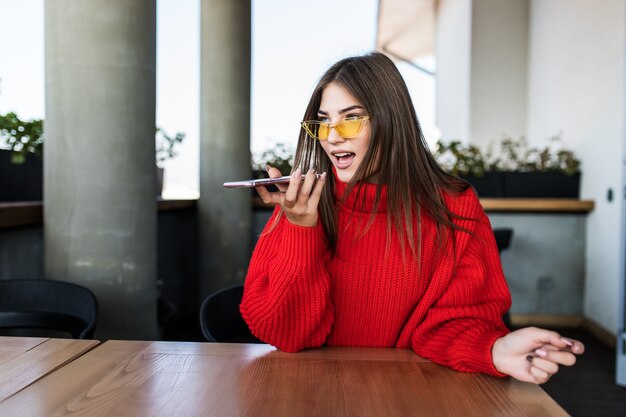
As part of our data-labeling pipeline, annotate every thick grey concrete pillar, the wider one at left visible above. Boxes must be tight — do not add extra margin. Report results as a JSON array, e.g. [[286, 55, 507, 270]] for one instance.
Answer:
[[44, 0, 158, 339]]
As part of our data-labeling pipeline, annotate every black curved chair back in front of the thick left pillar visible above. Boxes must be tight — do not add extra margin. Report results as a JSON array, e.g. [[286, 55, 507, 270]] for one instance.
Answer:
[[0, 279, 98, 339]]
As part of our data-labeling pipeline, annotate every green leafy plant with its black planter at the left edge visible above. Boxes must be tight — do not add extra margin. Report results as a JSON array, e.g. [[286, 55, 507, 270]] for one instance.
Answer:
[[0, 112, 43, 201]]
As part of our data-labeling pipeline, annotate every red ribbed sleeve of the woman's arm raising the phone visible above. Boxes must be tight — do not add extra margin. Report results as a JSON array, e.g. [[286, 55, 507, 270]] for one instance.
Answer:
[[240, 208, 334, 352]]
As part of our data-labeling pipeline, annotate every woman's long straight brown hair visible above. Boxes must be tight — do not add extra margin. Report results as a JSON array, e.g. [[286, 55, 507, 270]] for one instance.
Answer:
[[294, 52, 468, 255]]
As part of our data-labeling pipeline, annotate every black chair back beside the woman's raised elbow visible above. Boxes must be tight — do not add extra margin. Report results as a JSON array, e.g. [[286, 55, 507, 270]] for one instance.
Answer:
[[200, 285, 261, 343]]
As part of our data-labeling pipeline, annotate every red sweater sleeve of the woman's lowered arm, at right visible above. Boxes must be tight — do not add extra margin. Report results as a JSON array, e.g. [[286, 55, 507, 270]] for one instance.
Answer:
[[412, 192, 511, 376]]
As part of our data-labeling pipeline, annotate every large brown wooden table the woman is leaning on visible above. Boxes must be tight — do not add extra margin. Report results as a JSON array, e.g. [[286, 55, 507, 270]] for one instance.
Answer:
[[0, 341, 567, 417]]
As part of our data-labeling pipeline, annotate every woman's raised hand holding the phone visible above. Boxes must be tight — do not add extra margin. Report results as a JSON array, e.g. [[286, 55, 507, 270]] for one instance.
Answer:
[[255, 166, 326, 227]]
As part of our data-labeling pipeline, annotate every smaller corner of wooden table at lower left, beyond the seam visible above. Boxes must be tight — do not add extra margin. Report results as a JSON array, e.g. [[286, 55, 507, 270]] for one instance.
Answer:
[[0, 336, 99, 401]]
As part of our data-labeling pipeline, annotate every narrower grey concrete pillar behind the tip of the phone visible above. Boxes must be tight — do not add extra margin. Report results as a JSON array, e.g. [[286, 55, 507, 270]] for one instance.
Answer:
[[198, 0, 251, 297]]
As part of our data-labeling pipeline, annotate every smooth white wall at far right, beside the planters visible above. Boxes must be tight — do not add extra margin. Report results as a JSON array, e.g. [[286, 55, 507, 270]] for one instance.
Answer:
[[528, 0, 626, 333]]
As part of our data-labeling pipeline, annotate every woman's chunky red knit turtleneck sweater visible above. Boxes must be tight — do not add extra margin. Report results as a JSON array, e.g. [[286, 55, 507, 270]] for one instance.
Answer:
[[241, 174, 511, 376]]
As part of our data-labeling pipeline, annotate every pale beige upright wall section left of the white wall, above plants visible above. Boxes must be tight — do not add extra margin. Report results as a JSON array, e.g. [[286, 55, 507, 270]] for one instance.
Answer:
[[468, 0, 529, 148]]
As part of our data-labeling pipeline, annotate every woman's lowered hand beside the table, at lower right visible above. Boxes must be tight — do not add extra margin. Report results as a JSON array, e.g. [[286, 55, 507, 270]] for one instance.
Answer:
[[491, 327, 585, 384]]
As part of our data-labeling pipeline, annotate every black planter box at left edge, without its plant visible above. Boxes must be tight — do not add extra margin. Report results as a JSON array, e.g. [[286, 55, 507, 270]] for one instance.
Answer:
[[0, 150, 43, 202]]
